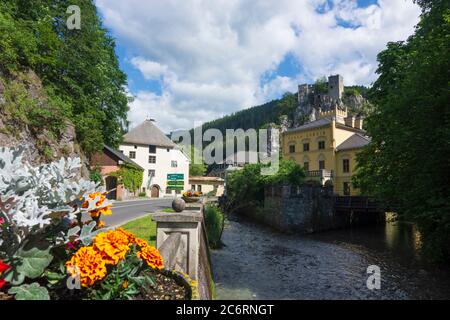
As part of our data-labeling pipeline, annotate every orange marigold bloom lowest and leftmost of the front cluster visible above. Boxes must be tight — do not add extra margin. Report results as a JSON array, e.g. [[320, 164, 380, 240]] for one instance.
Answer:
[[66, 246, 107, 287]]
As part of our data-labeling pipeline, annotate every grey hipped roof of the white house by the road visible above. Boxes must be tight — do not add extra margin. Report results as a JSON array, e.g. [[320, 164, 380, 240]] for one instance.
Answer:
[[123, 120, 175, 148]]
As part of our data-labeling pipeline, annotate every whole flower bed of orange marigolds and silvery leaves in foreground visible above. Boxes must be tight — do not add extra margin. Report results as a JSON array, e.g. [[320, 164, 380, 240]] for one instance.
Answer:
[[0, 148, 192, 300]]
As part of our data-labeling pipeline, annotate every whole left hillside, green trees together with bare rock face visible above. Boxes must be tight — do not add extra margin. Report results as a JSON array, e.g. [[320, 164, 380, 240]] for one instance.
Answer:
[[0, 0, 128, 164]]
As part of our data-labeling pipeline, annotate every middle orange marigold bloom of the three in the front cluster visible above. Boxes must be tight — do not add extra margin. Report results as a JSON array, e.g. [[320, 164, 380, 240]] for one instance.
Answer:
[[94, 230, 131, 265]]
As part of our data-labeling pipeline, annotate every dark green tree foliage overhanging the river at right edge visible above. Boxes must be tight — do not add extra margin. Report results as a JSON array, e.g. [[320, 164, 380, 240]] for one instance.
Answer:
[[355, 0, 450, 259]]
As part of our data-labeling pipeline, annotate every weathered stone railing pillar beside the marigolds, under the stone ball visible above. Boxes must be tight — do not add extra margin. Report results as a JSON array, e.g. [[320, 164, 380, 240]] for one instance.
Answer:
[[152, 203, 213, 300]]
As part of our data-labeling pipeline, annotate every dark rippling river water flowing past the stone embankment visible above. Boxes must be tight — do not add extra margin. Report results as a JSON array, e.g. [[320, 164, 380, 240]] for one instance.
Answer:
[[211, 216, 450, 299]]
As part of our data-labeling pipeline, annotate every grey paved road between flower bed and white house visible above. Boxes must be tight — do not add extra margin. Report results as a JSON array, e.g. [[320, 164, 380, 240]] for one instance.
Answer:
[[102, 198, 173, 226]]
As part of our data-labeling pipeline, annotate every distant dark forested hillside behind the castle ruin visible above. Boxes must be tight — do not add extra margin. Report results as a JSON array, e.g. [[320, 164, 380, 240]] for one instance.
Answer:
[[203, 86, 368, 133]]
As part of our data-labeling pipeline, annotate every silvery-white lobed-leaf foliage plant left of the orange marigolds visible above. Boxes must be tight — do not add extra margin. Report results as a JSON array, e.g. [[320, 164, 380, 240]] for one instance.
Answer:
[[0, 147, 110, 299]]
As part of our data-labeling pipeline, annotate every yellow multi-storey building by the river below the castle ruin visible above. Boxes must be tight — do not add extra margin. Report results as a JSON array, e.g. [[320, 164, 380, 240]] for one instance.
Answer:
[[281, 107, 370, 195]]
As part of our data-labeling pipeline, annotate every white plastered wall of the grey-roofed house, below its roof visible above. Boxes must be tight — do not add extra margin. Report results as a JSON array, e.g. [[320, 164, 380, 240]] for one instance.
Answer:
[[119, 144, 189, 197]]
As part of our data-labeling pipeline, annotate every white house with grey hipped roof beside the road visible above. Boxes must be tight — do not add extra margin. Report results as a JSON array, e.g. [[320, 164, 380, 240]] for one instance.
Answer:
[[120, 120, 190, 198]]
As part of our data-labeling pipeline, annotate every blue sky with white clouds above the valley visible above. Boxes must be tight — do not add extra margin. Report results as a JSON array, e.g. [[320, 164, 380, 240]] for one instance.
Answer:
[[95, 0, 420, 133]]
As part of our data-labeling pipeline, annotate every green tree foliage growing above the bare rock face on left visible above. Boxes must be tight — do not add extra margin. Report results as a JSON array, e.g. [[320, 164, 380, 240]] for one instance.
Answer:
[[0, 0, 128, 153]]
